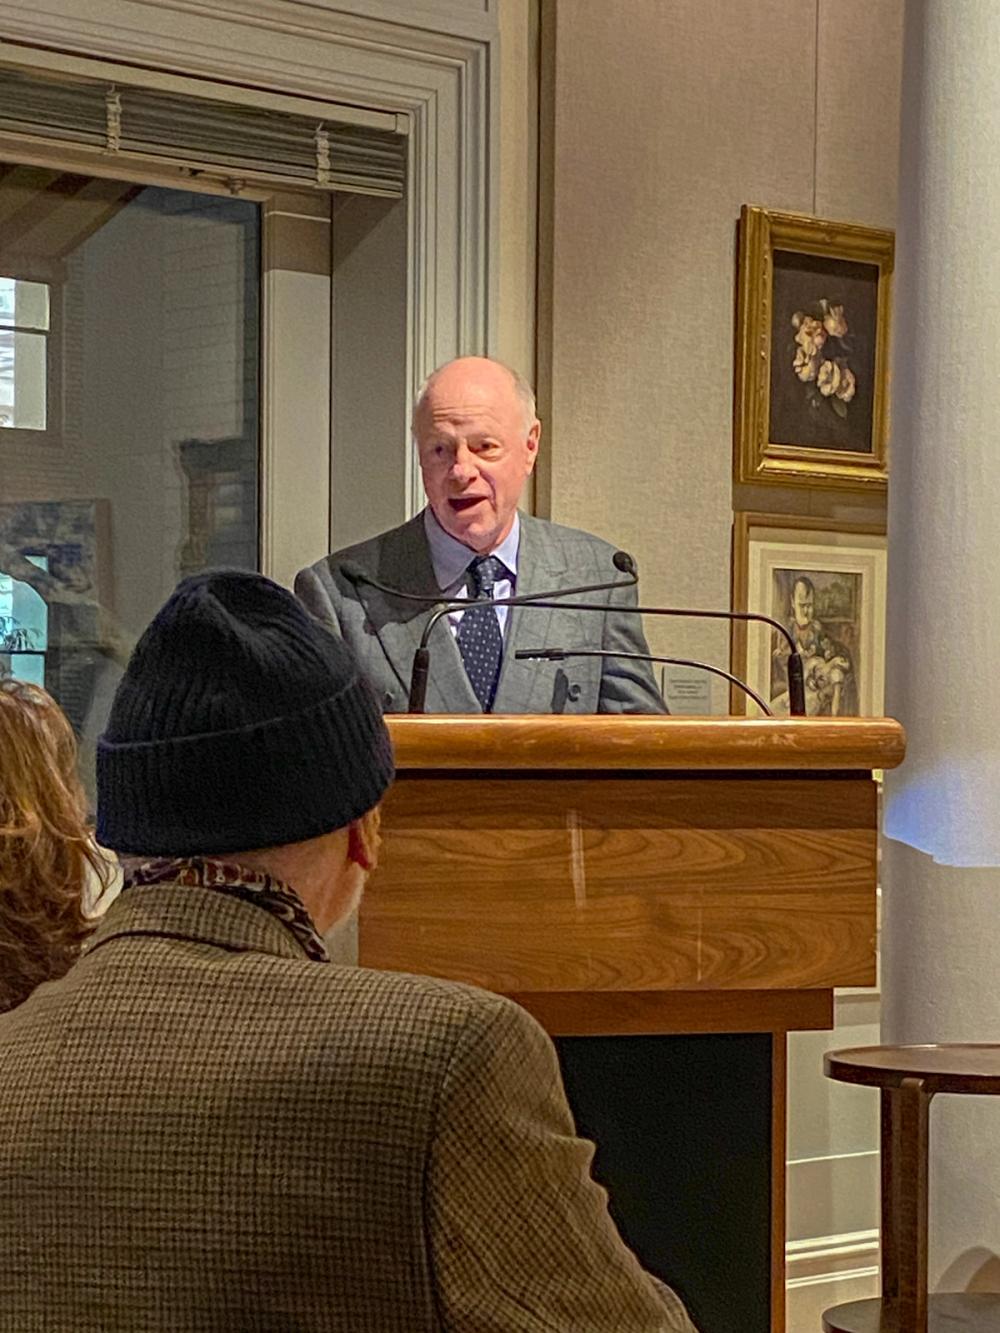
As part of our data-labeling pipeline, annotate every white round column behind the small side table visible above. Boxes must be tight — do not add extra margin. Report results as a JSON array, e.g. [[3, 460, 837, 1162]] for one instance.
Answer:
[[885, 0, 1000, 1289]]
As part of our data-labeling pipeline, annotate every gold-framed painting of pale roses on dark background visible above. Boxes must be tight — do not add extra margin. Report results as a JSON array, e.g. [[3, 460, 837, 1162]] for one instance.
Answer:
[[733, 205, 895, 488]]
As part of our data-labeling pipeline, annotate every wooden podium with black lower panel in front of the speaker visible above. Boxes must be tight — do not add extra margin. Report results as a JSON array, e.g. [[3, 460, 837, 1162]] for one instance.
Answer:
[[359, 716, 904, 1333]]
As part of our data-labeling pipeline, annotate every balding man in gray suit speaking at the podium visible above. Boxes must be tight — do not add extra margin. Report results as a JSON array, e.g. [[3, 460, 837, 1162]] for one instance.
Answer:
[[295, 356, 667, 713]]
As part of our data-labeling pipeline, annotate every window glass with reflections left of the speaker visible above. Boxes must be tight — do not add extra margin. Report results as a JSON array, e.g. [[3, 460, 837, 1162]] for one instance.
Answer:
[[0, 165, 260, 786]]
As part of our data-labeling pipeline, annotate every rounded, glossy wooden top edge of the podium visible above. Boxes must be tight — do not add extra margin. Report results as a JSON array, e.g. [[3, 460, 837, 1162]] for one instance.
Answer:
[[385, 713, 905, 770]]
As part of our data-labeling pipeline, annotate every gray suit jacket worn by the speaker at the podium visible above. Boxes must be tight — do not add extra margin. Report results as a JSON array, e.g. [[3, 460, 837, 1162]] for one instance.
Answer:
[[295, 515, 667, 713]]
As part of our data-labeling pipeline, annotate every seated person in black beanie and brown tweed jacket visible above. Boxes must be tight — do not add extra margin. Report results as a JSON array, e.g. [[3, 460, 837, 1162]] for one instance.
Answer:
[[0, 572, 692, 1333]]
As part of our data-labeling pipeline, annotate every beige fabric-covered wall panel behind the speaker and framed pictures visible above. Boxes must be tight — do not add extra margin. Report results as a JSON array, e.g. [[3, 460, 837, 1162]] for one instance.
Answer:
[[539, 0, 903, 710]]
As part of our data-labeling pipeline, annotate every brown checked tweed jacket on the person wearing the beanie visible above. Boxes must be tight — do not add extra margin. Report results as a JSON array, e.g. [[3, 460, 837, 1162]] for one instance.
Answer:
[[0, 884, 691, 1333]]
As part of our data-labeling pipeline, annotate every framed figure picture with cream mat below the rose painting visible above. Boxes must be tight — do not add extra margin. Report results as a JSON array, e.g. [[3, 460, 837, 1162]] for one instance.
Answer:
[[732, 513, 885, 717]]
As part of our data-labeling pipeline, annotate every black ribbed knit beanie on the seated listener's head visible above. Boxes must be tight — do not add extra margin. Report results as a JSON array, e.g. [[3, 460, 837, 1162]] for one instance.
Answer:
[[97, 571, 392, 856]]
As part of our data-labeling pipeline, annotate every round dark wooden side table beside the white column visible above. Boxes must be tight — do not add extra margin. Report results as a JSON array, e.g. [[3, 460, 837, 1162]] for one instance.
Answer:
[[823, 1042, 1000, 1333]]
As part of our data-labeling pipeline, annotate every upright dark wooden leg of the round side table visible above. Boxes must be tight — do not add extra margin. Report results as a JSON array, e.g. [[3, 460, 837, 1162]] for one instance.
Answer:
[[881, 1078, 932, 1333]]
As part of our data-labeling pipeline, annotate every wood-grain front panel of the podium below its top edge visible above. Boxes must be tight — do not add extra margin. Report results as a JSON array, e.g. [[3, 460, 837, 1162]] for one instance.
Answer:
[[360, 769, 876, 993]]
